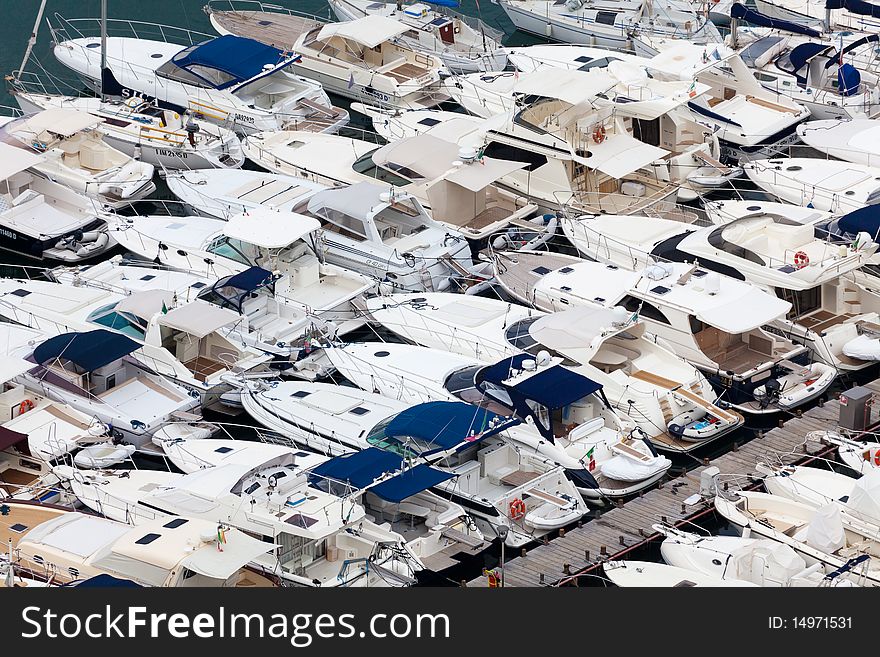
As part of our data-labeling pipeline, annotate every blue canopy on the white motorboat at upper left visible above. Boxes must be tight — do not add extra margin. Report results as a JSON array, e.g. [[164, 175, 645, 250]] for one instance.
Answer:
[[172, 34, 284, 89]]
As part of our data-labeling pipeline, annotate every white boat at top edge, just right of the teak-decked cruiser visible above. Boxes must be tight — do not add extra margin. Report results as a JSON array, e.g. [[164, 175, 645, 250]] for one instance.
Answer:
[[327, 0, 507, 73]]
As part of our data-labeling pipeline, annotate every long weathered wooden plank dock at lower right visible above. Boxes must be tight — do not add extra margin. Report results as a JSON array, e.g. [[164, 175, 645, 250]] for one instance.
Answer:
[[462, 379, 880, 587]]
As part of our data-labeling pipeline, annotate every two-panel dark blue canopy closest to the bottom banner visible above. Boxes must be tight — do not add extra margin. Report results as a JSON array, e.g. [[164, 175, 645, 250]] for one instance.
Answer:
[[311, 447, 454, 503]]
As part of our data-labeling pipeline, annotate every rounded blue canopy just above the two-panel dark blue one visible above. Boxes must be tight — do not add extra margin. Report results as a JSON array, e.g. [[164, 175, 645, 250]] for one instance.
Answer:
[[385, 402, 519, 456]]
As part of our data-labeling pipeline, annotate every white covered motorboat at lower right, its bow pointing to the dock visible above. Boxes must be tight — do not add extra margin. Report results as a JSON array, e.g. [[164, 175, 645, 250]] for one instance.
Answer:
[[653, 525, 863, 587]]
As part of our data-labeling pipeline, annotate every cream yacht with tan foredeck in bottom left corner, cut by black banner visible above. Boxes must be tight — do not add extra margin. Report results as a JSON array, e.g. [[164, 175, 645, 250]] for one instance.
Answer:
[[0, 501, 275, 588]]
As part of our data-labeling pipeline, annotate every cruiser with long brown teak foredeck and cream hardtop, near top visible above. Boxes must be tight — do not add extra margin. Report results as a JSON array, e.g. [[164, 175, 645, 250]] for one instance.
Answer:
[[209, 10, 448, 109]]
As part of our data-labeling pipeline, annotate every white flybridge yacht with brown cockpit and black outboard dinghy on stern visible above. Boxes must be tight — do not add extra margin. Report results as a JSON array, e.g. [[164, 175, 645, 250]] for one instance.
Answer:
[[495, 251, 837, 413]]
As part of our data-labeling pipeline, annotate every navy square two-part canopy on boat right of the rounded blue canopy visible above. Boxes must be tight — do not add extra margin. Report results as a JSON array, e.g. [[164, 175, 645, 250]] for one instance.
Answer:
[[478, 354, 602, 410]]
